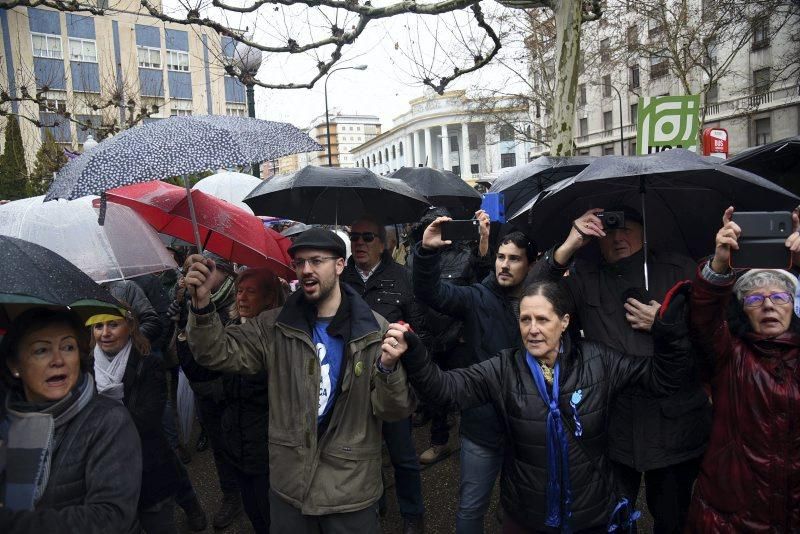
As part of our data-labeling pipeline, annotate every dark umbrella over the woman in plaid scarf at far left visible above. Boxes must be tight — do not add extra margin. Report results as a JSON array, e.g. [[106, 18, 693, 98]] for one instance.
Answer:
[[0, 236, 120, 326]]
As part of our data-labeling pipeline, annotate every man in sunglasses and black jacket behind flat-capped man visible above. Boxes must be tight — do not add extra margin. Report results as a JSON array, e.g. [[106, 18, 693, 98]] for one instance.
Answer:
[[341, 217, 425, 534]]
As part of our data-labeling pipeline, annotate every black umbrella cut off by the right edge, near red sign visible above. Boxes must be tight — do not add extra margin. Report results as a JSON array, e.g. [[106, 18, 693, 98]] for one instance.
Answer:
[[723, 135, 800, 194]]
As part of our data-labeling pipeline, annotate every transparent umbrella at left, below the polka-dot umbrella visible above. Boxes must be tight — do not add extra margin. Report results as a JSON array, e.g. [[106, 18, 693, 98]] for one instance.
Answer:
[[0, 196, 176, 282]]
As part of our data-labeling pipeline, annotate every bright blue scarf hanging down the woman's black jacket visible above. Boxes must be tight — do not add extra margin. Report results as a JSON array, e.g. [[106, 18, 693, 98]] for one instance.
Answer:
[[526, 353, 572, 532]]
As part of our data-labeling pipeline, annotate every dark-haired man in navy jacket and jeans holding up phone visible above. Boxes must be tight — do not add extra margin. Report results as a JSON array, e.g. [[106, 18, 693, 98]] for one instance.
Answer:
[[412, 211, 536, 534]]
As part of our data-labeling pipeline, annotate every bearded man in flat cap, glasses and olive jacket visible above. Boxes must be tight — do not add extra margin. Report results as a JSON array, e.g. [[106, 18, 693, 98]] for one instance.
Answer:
[[186, 228, 414, 534]]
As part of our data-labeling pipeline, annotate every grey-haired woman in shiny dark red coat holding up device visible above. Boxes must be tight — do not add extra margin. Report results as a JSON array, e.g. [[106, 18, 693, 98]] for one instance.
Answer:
[[687, 208, 800, 534]]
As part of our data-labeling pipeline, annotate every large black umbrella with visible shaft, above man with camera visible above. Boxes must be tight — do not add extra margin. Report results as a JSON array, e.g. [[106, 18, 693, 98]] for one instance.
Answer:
[[511, 149, 800, 287]]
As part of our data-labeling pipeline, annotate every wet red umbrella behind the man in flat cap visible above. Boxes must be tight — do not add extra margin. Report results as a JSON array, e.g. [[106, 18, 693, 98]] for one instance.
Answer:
[[101, 181, 295, 280]]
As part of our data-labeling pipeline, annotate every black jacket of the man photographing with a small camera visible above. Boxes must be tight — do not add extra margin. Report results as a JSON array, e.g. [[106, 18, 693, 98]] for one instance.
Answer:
[[527, 249, 711, 472]]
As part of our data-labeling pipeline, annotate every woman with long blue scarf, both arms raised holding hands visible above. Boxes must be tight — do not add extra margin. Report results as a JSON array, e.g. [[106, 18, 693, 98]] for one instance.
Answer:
[[381, 282, 691, 534]]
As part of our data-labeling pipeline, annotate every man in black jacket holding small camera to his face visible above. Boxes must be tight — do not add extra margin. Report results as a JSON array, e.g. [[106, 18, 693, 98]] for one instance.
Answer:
[[528, 207, 711, 533]]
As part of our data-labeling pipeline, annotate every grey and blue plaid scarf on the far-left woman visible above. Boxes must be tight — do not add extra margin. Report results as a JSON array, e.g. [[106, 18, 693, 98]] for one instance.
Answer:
[[0, 373, 94, 511]]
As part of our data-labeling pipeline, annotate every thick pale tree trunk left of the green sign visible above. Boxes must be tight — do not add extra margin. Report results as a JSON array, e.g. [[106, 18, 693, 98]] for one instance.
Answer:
[[550, 0, 582, 156]]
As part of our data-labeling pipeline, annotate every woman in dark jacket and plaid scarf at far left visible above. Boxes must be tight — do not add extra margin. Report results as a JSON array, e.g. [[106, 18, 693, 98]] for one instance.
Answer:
[[0, 308, 142, 534]]
